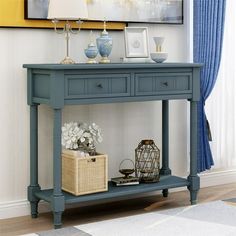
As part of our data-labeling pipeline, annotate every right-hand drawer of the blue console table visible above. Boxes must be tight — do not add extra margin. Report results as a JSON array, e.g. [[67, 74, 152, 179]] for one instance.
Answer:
[[135, 73, 192, 96]]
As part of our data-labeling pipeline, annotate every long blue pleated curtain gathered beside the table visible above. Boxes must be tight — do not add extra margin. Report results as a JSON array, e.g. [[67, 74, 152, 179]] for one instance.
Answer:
[[193, 0, 226, 172]]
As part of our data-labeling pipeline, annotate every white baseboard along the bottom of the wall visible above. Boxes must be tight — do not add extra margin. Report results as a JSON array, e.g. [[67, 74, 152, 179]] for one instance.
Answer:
[[0, 170, 236, 219]]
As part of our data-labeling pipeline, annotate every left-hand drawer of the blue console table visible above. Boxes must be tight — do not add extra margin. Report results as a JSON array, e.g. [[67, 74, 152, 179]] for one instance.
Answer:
[[65, 74, 130, 98]]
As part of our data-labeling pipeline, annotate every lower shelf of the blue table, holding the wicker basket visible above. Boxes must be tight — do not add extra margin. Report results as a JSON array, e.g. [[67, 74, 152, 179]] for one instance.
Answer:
[[35, 175, 189, 204]]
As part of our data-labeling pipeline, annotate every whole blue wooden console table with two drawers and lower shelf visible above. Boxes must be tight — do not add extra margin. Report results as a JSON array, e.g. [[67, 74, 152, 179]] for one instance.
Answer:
[[23, 63, 202, 228]]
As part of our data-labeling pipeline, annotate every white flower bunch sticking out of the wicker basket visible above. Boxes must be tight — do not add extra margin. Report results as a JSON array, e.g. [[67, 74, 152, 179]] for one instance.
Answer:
[[61, 122, 103, 153]]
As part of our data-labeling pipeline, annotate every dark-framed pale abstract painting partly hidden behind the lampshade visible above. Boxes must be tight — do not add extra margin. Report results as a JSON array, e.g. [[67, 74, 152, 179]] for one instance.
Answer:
[[25, 0, 183, 24]]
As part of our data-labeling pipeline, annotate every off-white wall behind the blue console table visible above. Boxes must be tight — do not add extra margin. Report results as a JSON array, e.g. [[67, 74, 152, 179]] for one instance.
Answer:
[[0, 3, 192, 218]]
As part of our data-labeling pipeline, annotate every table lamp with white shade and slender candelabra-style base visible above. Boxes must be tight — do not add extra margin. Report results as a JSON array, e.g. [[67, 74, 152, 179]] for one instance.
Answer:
[[48, 0, 88, 64]]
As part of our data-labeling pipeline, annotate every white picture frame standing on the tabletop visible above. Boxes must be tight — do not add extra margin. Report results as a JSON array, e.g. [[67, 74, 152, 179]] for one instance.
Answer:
[[125, 27, 149, 58]]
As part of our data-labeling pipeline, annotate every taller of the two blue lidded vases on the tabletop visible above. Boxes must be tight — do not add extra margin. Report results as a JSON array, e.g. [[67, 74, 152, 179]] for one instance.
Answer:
[[96, 29, 112, 63]]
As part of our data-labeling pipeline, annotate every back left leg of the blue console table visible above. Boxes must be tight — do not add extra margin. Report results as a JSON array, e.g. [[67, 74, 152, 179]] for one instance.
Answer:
[[28, 104, 40, 218]]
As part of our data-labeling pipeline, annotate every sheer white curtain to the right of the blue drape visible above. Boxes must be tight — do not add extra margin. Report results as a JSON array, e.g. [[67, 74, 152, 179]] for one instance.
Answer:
[[205, 0, 236, 171]]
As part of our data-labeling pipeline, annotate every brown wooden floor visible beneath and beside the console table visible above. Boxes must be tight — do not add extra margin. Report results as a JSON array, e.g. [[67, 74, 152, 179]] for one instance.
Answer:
[[0, 184, 236, 236]]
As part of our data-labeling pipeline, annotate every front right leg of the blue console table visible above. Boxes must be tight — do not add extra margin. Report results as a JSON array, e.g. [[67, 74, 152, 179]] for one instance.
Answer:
[[188, 101, 200, 205]]
